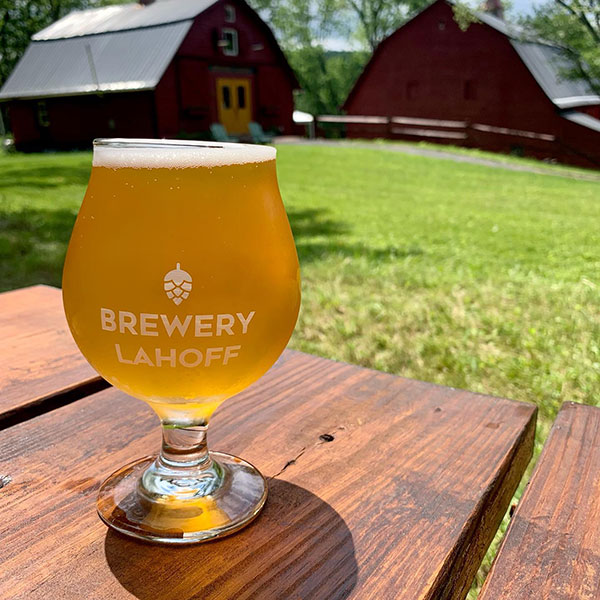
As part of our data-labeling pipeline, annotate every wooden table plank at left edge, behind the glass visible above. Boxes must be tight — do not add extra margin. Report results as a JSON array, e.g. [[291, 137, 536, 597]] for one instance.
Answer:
[[0, 285, 108, 428]]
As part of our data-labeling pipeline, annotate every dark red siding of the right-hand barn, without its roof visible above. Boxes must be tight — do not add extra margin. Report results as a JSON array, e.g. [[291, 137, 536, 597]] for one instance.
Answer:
[[344, 0, 600, 166]]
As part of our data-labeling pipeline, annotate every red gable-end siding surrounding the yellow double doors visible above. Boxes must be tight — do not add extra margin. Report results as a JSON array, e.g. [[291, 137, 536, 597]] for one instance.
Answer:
[[156, 0, 296, 137]]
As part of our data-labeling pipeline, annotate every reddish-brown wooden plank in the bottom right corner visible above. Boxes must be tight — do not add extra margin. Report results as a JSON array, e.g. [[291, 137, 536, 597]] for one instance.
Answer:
[[480, 402, 600, 600]]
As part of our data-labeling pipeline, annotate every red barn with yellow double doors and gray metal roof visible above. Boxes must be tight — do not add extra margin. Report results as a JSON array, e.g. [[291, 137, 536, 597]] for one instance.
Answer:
[[0, 0, 298, 150]]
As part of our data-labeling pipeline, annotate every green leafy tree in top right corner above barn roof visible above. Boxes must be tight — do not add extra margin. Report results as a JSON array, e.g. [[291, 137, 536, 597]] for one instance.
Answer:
[[525, 0, 600, 93]]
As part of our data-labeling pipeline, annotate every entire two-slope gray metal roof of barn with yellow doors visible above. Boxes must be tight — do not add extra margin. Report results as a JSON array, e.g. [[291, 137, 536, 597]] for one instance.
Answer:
[[0, 0, 298, 100]]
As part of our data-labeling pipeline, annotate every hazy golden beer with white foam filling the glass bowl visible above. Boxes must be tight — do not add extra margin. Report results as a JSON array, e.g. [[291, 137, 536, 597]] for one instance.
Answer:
[[63, 143, 300, 424]]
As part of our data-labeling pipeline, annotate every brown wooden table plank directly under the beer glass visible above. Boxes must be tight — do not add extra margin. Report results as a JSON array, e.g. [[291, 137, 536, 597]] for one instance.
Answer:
[[0, 351, 536, 600]]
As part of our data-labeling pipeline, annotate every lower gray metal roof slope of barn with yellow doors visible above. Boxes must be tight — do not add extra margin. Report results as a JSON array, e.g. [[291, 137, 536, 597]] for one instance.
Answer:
[[0, 22, 193, 100]]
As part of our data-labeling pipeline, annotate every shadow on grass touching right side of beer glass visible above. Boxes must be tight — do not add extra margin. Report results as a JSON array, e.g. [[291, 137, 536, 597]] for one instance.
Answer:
[[287, 208, 424, 264]]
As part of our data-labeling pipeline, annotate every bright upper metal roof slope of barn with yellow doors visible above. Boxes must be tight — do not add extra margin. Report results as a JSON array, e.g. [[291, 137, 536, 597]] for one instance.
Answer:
[[31, 0, 217, 41]]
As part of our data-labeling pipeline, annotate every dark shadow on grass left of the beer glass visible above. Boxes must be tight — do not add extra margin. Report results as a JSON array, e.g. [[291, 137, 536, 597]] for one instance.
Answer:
[[0, 208, 76, 291]]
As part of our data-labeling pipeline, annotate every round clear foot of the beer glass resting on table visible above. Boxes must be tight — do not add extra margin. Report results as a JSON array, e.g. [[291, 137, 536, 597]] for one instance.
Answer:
[[97, 452, 267, 544]]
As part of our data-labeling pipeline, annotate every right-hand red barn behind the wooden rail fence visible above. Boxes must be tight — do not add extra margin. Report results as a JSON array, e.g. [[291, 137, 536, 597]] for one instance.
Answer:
[[344, 0, 600, 168]]
